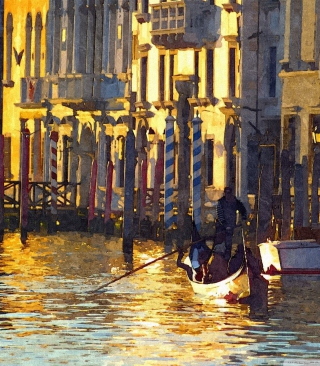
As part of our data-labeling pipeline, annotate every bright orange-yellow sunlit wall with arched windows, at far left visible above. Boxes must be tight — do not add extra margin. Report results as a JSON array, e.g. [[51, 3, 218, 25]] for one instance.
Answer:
[[3, 0, 49, 180]]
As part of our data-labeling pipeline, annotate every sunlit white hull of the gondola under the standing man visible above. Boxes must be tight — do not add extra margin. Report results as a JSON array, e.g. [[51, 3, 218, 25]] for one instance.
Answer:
[[184, 256, 250, 300]]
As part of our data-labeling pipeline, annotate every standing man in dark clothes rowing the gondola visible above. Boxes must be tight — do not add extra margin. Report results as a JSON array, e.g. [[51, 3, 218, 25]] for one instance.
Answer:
[[217, 187, 247, 261]]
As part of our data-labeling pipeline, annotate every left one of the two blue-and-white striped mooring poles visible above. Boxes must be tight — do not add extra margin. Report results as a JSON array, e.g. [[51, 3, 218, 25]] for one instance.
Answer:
[[164, 115, 175, 230]]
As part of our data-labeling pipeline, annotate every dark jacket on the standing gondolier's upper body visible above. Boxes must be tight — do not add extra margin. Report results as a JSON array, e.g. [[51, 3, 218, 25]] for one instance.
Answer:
[[217, 197, 247, 227]]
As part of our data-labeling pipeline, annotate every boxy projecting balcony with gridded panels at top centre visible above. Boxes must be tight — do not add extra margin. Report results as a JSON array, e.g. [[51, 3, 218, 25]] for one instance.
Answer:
[[150, 0, 217, 49]]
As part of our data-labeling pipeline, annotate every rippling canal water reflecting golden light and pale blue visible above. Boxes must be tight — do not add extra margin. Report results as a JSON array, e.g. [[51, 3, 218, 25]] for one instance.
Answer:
[[0, 233, 320, 366]]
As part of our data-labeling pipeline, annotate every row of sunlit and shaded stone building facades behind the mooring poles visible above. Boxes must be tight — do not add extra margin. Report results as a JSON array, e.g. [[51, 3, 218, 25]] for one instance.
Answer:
[[3, 0, 320, 236]]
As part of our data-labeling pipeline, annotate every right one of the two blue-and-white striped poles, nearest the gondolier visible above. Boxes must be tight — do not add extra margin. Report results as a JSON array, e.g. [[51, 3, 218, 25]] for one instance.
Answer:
[[192, 112, 202, 231]]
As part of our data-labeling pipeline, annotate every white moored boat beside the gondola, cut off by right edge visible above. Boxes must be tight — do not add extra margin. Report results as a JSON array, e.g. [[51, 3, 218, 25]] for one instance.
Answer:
[[258, 240, 320, 274]]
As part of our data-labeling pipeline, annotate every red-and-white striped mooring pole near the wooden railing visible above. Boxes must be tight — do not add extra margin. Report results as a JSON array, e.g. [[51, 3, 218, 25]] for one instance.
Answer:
[[50, 131, 59, 232]]
